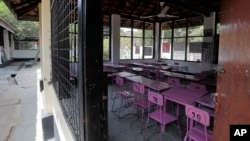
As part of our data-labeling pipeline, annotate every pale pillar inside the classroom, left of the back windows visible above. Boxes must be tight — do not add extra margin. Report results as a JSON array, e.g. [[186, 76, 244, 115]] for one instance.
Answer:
[[111, 14, 121, 64]]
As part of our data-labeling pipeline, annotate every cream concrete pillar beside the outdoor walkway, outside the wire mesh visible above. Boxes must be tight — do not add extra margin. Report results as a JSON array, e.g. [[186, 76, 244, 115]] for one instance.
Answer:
[[39, 0, 53, 114]]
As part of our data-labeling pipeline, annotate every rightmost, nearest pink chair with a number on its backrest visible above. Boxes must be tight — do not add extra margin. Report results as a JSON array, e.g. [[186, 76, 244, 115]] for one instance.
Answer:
[[184, 105, 212, 141]]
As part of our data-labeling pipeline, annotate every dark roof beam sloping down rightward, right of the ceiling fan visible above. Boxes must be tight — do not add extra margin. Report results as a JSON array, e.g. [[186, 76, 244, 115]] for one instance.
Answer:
[[165, 0, 210, 17]]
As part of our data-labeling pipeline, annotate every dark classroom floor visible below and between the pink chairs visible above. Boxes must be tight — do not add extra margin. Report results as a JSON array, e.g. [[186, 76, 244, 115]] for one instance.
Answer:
[[108, 85, 185, 141]]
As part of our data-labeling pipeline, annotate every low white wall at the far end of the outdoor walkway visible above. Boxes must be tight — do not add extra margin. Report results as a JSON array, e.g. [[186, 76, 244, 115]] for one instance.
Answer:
[[13, 50, 40, 59]]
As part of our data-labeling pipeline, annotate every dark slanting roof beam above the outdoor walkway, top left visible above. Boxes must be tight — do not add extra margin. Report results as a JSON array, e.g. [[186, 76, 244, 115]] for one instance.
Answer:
[[15, 0, 40, 18]]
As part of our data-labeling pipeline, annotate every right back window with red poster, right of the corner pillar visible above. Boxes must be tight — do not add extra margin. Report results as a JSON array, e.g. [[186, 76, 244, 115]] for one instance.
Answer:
[[160, 17, 204, 62]]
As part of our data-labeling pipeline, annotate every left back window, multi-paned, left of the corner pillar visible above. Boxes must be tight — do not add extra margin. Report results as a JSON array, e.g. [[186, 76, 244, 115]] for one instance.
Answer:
[[120, 19, 154, 59]]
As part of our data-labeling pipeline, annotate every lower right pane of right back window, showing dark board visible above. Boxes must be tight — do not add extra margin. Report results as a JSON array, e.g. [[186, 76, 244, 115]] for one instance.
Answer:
[[187, 37, 203, 62]]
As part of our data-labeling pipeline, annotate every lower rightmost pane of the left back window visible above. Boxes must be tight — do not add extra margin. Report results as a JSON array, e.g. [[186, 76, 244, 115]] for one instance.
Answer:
[[144, 39, 154, 59]]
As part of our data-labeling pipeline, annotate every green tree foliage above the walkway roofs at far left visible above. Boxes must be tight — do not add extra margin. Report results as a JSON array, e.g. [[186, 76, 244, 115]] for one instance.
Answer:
[[0, 0, 39, 40]]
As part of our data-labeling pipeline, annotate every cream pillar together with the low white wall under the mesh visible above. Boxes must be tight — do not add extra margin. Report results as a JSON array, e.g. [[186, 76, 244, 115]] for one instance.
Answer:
[[39, 0, 74, 141]]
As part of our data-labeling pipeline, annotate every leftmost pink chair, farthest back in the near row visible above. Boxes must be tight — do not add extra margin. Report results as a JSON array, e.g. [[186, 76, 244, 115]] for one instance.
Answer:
[[111, 76, 134, 118]]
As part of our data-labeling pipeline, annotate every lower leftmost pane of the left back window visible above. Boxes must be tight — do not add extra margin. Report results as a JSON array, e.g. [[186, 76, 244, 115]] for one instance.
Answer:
[[120, 37, 131, 59]]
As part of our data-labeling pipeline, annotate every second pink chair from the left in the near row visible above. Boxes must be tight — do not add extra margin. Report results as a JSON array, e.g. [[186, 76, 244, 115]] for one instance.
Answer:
[[130, 83, 155, 131]]
